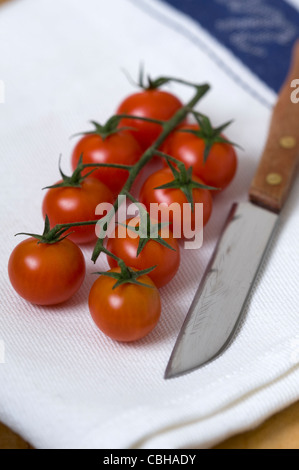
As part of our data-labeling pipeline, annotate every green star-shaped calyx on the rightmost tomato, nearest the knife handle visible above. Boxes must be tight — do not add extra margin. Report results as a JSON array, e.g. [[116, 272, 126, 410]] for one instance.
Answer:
[[178, 111, 239, 163]]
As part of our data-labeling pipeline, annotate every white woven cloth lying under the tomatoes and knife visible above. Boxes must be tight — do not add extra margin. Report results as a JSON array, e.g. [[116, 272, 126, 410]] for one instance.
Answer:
[[0, 0, 299, 449]]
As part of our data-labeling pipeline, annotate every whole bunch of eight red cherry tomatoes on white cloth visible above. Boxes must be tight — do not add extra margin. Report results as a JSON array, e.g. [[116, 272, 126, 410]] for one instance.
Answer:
[[8, 76, 237, 341]]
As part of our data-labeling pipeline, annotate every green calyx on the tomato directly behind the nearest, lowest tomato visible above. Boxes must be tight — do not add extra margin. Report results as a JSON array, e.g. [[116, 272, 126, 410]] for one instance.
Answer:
[[118, 191, 176, 256]]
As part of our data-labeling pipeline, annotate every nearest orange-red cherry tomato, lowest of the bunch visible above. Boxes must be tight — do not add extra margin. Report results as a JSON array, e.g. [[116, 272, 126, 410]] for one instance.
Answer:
[[89, 268, 161, 341]]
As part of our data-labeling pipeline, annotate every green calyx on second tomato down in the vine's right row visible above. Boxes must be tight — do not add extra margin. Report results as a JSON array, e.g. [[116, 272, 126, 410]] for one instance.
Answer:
[[154, 151, 218, 212]]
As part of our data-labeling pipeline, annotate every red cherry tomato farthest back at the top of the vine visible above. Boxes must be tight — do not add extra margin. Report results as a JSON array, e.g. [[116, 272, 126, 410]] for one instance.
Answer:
[[117, 89, 183, 149]]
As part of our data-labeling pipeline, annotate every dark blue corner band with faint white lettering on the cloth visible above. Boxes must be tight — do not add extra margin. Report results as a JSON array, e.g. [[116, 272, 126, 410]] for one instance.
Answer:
[[163, 0, 299, 91]]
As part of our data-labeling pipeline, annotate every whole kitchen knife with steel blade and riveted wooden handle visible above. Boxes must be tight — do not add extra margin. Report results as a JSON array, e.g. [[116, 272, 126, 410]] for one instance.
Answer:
[[165, 41, 299, 379]]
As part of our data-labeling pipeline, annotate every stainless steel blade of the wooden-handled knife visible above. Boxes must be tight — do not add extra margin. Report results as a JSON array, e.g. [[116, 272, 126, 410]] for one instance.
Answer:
[[165, 202, 279, 378]]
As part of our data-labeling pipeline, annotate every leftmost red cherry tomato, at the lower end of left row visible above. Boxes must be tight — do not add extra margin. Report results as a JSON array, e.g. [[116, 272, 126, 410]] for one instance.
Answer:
[[8, 238, 85, 305]]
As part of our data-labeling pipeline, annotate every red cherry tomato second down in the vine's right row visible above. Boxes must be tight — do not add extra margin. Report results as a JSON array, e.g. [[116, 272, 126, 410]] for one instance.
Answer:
[[139, 168, 213, 238]]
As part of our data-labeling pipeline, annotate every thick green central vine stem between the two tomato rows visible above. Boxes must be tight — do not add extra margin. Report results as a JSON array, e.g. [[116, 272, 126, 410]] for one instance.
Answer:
[[91, 79, 210, 263]]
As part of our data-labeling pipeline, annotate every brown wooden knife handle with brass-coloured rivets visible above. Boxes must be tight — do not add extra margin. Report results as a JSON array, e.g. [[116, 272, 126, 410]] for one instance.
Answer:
[[249, 40, 299, 212]]
